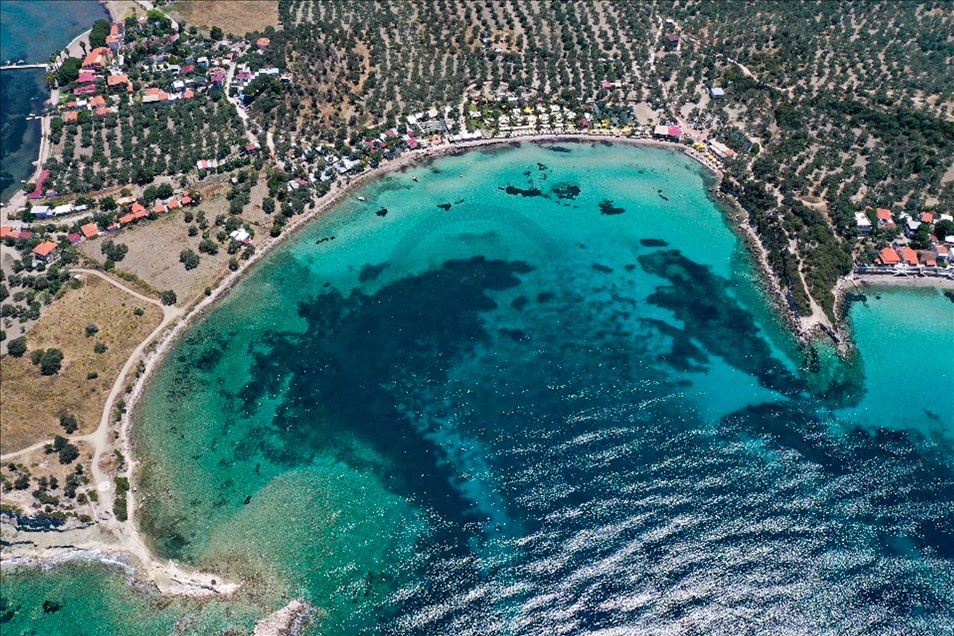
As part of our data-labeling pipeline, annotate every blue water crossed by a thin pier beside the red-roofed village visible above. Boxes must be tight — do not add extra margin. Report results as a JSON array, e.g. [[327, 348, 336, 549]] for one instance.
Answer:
[[0, 0, 109, 201]]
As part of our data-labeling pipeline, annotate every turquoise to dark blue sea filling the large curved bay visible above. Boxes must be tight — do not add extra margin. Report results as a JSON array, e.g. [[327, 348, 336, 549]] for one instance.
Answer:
[[4, 144, 954, 634]]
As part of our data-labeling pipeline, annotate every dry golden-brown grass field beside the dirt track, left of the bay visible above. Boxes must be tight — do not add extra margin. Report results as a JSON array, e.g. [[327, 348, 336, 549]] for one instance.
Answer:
[[0, 277, 162, 453]]
